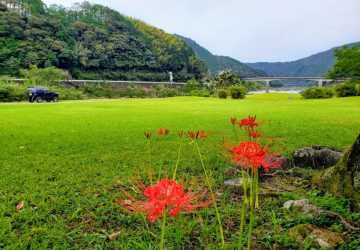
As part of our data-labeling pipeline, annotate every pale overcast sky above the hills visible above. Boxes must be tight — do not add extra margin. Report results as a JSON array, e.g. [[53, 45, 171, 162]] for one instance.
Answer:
[[44, 0, 360, 62]]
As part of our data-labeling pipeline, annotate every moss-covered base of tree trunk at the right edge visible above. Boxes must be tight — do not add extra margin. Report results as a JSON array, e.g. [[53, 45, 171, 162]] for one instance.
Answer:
[[311, 135, 360, 211]]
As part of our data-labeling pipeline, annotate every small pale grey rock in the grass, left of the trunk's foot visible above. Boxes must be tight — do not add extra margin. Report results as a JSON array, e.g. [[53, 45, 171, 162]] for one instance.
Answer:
[[283, 199, 321, 219]]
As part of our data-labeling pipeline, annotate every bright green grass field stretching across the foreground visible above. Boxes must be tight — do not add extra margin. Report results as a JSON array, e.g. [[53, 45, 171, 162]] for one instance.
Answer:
[[0, 94, 360, 249]]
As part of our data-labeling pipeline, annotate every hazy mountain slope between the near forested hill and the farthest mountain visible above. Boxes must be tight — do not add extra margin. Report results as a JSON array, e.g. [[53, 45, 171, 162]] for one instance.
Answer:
[[175, 34, 266, 77]]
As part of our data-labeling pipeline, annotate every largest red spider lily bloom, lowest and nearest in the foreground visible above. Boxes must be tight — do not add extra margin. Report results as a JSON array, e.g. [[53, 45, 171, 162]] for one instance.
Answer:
[[118, 178, 211, 222]]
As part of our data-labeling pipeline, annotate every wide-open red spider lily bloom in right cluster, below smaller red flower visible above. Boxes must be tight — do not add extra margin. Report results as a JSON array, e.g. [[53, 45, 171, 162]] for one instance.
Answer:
[[228, 142, 283, 172]]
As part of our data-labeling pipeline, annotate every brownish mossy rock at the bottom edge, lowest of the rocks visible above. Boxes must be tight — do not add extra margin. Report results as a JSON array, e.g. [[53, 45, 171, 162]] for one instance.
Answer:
[[289, 225, 344, 249]]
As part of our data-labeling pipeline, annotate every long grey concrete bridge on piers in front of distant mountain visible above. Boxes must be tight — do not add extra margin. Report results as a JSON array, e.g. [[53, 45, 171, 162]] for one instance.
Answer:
[[242, 76, 347, 93]]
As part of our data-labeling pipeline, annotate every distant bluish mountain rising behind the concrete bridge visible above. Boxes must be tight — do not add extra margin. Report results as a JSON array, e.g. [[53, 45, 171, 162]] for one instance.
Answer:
[[247, 43, 356, 76]]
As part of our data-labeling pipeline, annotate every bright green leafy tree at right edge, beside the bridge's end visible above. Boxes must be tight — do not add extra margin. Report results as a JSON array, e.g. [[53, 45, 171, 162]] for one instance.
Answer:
[[327, 45, 360, 80]]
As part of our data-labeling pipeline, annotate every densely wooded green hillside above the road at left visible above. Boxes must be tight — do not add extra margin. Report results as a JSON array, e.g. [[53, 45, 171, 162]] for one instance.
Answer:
[[0, 0, 208, 81]]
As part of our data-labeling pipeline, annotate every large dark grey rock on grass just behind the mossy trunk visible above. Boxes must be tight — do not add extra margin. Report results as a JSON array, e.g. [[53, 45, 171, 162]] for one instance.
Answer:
[[293, 146, 343, 169]]
